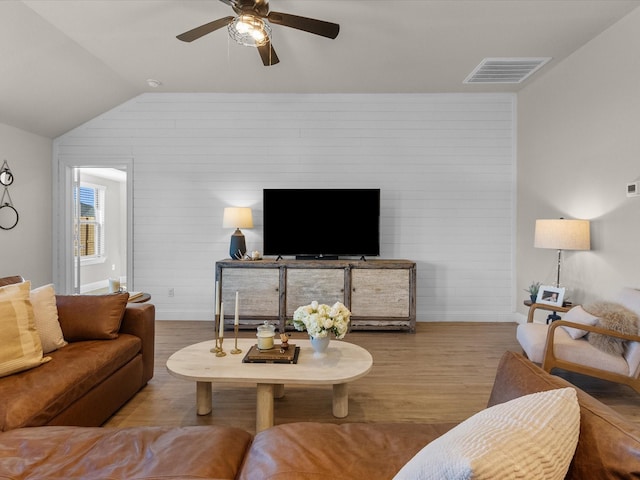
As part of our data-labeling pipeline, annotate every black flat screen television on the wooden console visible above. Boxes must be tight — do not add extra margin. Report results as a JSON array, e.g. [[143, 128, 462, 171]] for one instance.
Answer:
[[263, 188, 380, 259]]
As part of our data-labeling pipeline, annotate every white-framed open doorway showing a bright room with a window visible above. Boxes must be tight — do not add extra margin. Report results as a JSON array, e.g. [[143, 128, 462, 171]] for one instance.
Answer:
[[54, 160, 133, 294]]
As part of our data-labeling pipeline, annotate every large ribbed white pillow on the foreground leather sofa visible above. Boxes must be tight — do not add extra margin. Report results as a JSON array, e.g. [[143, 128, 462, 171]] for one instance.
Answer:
[[394, 388, 580, 480]]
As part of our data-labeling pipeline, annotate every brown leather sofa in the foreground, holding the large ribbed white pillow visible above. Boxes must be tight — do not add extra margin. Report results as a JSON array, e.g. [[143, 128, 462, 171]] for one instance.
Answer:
[[0, 352, 640, 480]]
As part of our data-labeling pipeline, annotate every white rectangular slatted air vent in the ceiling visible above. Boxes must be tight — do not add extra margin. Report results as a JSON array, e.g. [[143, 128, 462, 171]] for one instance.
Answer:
[[463, 57, 551, 83]]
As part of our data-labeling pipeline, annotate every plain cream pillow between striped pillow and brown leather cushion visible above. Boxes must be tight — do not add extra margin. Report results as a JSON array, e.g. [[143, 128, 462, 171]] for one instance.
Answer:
[[31, 284, 67, 353]]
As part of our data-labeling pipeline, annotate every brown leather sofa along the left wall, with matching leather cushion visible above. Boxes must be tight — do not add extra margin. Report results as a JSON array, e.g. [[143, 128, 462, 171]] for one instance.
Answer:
[[0, 277, 155, 432]]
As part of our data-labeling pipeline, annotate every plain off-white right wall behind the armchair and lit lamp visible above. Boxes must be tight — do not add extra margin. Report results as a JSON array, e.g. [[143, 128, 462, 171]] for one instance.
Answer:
[[516, 5, 640, 312]]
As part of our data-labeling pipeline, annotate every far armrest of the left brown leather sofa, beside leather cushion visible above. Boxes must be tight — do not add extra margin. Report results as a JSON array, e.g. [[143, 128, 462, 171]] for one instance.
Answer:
[[120, 303, 156, 383]]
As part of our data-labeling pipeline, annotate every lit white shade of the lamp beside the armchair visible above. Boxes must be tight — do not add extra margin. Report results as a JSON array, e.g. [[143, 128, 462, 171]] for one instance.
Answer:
[[533, 218, 591, 250]]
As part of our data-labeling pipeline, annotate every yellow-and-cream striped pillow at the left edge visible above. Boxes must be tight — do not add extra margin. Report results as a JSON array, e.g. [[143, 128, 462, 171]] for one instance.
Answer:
[[0, 282, 51, 377]]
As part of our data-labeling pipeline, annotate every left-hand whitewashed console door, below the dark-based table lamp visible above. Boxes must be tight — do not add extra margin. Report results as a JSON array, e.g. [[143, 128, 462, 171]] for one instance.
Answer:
[[222, 268, 280, 318]]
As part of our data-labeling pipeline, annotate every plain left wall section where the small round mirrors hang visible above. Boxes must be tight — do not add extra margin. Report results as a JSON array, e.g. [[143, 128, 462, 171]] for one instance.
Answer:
[[0, 124, 52, 287]]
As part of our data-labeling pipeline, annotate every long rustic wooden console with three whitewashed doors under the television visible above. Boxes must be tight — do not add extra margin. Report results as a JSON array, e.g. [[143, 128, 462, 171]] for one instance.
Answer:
[[215, 257, 416, 333]]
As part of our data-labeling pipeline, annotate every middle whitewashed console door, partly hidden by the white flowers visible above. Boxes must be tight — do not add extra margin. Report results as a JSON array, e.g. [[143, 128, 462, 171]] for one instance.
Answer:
[[286, 268, 344, 318]]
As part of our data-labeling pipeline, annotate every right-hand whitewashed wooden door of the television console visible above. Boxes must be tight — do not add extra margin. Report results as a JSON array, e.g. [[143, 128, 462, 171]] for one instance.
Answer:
[[351, 268, 410, 318]]
